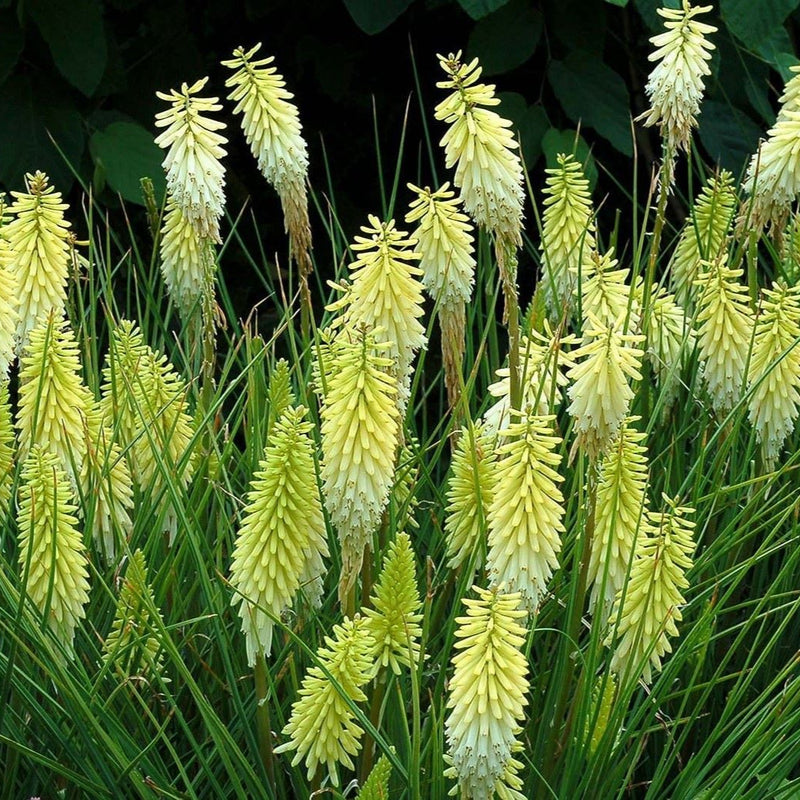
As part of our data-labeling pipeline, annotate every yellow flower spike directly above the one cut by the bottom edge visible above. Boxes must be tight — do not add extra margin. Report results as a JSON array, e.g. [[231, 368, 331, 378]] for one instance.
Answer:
[[486, 415, 564, 611]]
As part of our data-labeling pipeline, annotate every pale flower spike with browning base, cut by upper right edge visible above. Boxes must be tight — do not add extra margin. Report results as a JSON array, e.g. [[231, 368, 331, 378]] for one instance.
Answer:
[[739, 67, 800, 230]]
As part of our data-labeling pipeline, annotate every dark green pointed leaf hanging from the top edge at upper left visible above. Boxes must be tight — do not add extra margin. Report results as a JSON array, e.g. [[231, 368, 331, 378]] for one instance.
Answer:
[[25, 0, 107, 97]]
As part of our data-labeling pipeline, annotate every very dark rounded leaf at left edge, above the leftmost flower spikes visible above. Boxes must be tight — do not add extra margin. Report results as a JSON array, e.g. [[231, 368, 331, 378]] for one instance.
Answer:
[[0, 75, 85, 192]]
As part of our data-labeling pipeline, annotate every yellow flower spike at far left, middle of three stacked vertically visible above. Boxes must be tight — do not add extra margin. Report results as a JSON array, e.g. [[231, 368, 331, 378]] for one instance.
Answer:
[[17, 316, 95, 490]]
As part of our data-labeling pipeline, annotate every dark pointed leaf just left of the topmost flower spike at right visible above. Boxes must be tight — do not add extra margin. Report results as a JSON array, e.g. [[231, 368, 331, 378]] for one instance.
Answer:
[[547, 50, 633, 156]]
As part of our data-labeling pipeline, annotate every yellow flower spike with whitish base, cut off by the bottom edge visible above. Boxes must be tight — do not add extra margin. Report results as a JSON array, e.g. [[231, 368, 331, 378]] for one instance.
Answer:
[[445, 586, 528, 800]]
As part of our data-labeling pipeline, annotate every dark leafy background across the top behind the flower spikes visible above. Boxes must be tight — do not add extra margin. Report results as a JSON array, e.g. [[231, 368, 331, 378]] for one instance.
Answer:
[[0, 0, 800, 300]]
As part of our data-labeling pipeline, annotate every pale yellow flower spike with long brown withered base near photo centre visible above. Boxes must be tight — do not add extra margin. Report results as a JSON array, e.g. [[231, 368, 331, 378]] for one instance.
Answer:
[[406, 183, 475, 408]]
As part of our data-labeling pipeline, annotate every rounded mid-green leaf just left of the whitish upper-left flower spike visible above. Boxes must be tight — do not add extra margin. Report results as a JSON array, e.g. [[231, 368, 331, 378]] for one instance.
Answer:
[[89, 122, 166, 205]]
